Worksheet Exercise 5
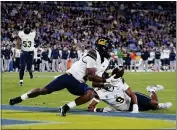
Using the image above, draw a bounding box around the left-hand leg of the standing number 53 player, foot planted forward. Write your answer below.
[19,51,26,86]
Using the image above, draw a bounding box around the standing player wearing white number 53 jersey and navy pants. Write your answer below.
[16,22,36,86]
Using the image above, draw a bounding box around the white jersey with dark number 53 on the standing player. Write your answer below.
[18,31,36,51]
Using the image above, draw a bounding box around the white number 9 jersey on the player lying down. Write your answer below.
[96,78,131,111]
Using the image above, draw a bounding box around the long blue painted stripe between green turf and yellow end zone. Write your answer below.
[1,105,176,120]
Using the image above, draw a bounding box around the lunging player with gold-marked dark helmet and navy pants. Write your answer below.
[9,38,117,116]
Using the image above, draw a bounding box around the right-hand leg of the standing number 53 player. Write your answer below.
[26,52,34,79]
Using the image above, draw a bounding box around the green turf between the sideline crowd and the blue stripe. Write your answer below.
[2,72,176,114]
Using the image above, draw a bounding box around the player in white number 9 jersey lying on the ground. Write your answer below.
[88,68,172,113]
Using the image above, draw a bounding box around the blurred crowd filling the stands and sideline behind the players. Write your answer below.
[1,1,176,71]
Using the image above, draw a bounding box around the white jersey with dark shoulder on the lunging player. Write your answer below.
[67,50,101,82]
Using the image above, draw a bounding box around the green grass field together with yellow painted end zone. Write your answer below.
[2,72,176,129]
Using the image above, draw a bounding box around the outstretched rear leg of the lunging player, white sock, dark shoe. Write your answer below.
[9,74,68,105]
